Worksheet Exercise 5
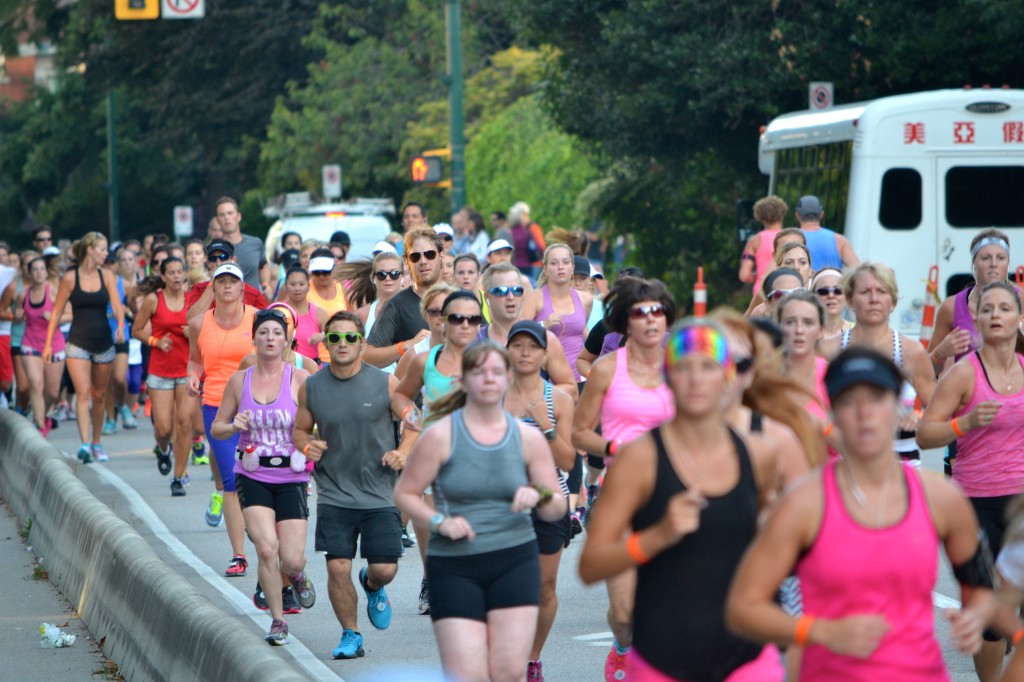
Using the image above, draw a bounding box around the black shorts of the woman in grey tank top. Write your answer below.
[427,541,541,623]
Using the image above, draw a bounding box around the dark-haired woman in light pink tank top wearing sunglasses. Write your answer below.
[572,278,676,680]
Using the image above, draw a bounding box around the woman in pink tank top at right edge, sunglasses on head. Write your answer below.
[918,281,1024,681]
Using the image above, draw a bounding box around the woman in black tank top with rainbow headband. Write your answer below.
[580,319,784,682]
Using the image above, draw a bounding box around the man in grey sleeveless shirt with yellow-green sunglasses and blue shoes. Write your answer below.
[294,311,414,658]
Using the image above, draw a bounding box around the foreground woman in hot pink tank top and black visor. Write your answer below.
[726,347,995,682]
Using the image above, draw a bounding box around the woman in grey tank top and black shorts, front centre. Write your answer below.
[394,341,565,680]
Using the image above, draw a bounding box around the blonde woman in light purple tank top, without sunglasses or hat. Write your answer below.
[522,244,594,383]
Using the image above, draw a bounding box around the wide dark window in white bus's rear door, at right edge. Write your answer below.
[946,166,1024,227]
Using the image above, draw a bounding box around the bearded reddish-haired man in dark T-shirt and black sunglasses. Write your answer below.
[364,228,443,368]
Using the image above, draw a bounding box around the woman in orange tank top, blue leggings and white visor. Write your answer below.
[187,262,260,578]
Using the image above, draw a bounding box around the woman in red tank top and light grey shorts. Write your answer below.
[131,257,196,489]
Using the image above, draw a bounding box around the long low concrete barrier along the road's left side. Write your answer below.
[0,410,308,682]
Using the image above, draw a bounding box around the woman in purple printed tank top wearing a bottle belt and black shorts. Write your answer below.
[207,306,316,646]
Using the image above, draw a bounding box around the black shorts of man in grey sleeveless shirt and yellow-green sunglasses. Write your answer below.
[313,504,401,563]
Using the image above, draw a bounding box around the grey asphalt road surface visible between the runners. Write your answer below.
[37,411,977,682]
